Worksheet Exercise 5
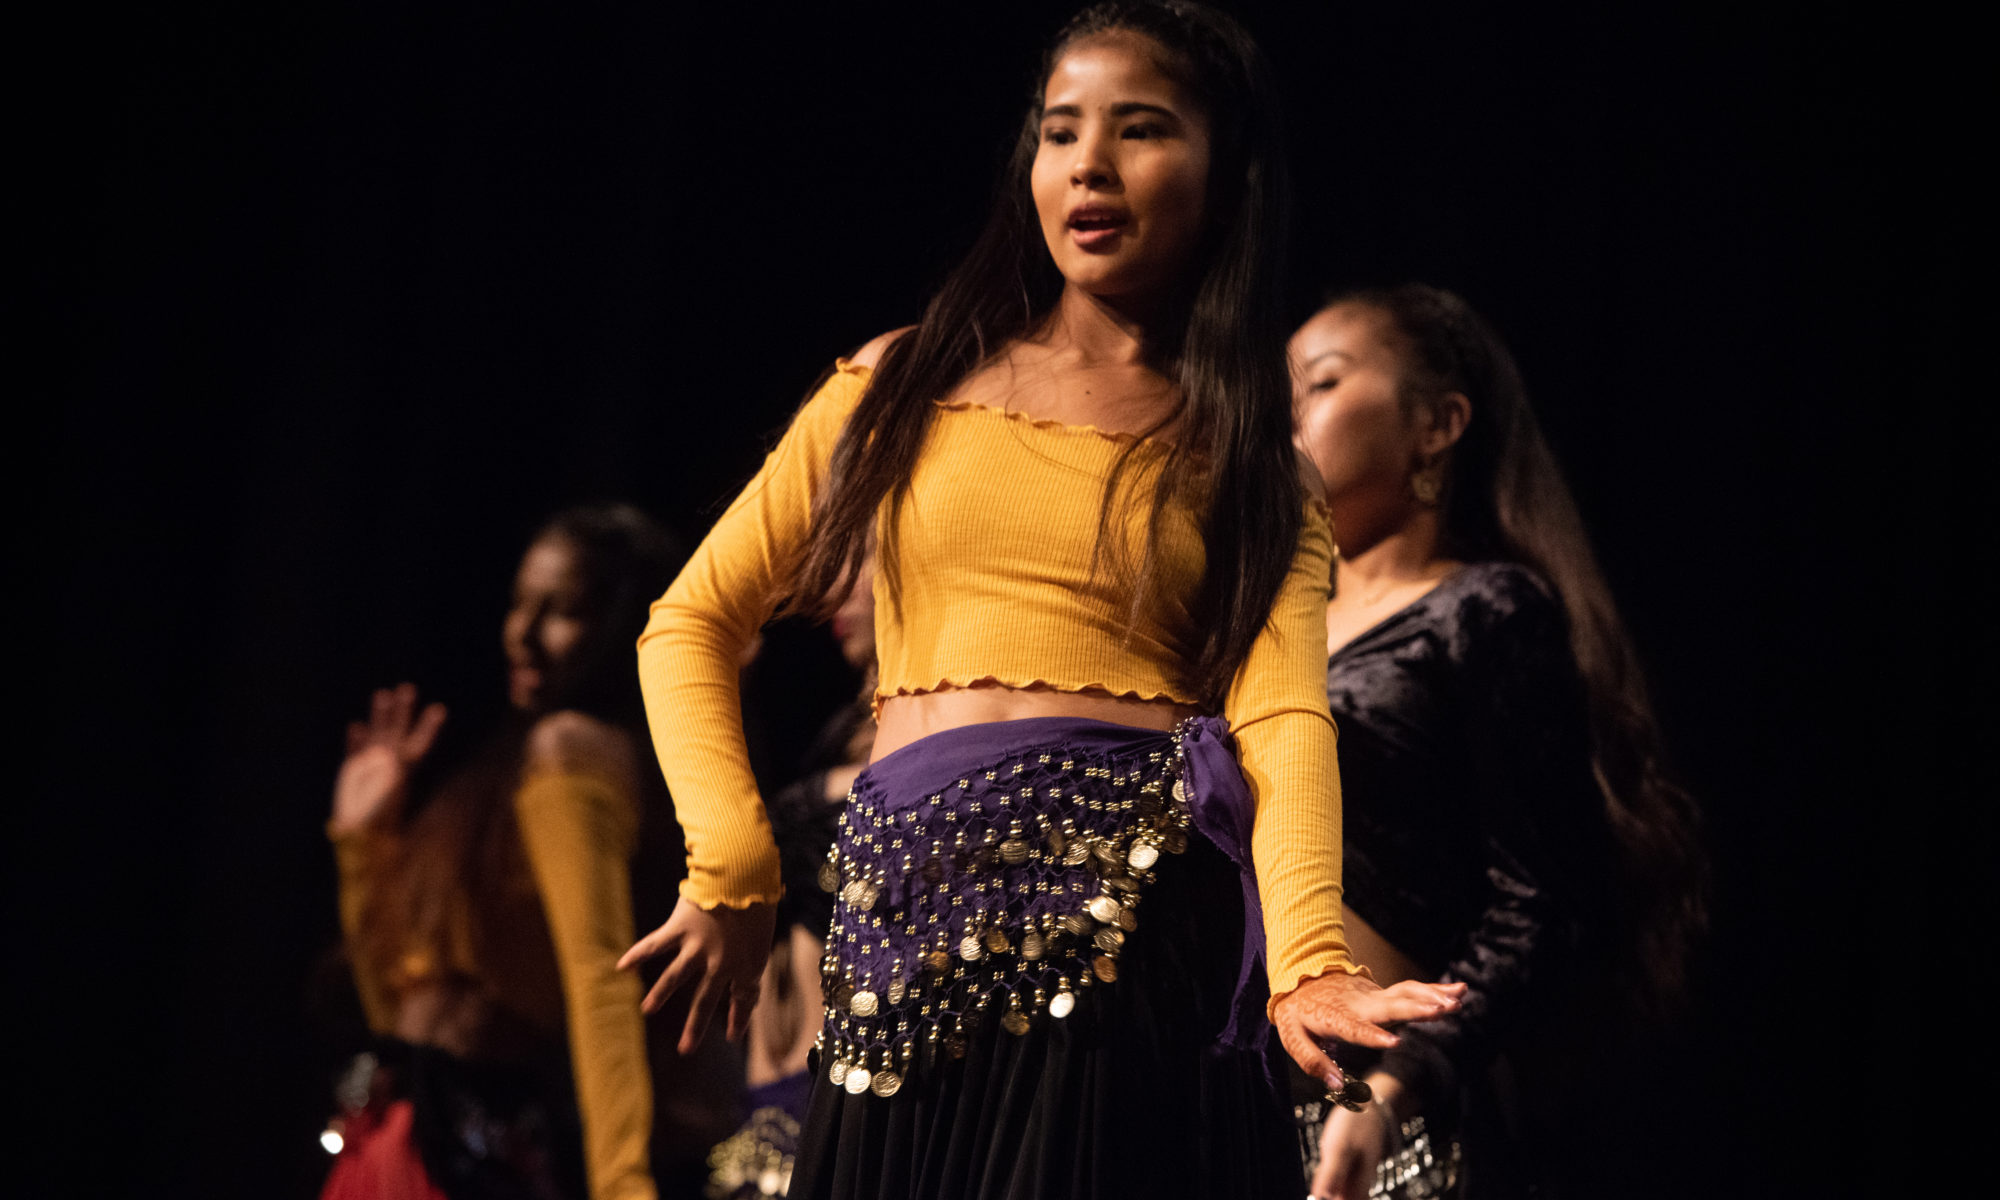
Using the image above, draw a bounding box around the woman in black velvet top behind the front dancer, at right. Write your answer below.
[1290,284,1702,1200]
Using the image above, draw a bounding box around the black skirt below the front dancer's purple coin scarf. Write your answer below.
[790,722,1302,1200]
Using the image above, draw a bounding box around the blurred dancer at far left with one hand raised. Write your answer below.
[326,506,732,1200]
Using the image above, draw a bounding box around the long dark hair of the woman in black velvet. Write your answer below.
[1322,284,1706,1016]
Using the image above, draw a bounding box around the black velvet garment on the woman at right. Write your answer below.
[1326,562,1612,1200]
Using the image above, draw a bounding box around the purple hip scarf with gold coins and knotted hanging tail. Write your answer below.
[818,716,1268,1096]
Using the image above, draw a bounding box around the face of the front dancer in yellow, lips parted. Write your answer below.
[1032,32,1208,298]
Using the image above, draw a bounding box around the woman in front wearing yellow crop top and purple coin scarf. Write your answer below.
[628,2,1456,1200]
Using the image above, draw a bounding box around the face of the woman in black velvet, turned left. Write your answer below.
[1290,304,1428,504]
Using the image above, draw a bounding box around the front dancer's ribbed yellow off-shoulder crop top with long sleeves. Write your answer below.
[638,362,1360,998]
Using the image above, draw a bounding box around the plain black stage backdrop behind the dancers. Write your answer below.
[35,2,1984,1196]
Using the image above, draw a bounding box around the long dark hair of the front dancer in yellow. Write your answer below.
[792,0,1302,704]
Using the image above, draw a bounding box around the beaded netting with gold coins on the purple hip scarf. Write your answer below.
[818,732,1190,1096]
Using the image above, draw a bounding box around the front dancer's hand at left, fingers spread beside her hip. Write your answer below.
[618,896,778,1054]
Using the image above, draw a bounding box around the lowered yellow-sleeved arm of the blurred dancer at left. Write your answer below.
[514,712,656,1200]
